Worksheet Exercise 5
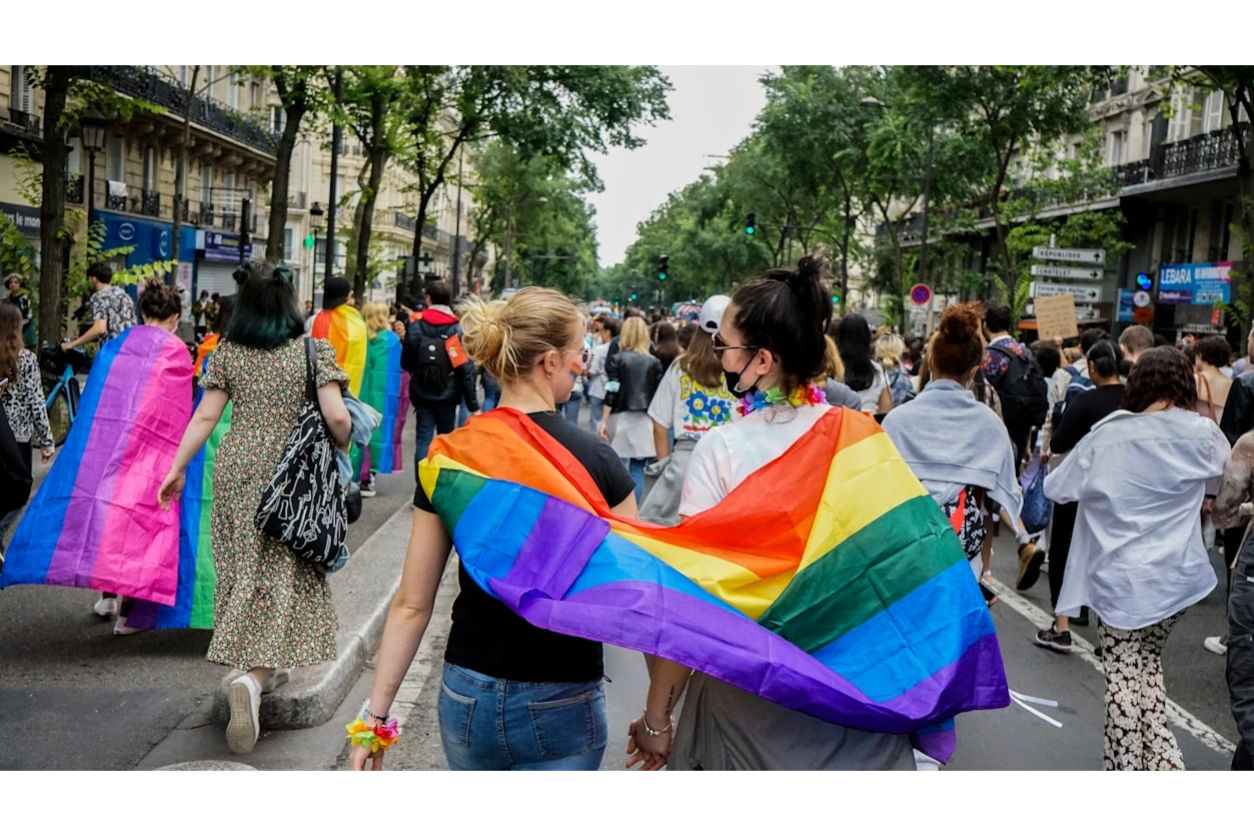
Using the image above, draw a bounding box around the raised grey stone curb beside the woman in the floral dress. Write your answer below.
[212,505,414,731]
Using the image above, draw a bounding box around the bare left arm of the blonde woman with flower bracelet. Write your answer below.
[351,508,453,772]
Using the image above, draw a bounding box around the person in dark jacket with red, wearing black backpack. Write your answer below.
[400,281,476,479]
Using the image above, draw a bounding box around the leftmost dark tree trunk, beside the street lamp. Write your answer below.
[39,64,71,345]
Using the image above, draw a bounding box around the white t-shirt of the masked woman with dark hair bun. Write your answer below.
[680,404,831,516]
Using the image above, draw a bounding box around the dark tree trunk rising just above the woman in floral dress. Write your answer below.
[239,64,329,264]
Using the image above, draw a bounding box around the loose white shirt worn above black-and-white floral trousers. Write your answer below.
[1045,409,1230,630]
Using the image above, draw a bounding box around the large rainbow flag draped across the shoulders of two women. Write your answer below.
[420,409,1009,761]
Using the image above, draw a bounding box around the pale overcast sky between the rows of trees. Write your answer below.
[592,64,775,266]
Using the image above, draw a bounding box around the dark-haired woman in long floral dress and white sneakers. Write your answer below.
[161,267,351,755]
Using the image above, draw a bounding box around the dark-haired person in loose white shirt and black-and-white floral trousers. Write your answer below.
[1045,347,1230,772]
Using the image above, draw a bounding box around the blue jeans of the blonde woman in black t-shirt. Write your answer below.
[439,663,608,773]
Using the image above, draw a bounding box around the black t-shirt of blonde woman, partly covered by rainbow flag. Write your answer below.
[414,412,636,682]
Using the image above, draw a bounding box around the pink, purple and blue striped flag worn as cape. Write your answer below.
[0,325,192,604]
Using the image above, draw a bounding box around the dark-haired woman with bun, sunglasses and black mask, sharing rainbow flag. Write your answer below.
[630,258,915,775]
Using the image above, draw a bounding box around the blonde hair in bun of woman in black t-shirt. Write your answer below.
[461,287,583,381]
